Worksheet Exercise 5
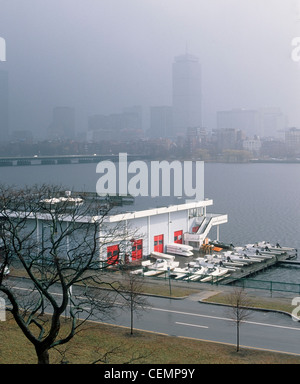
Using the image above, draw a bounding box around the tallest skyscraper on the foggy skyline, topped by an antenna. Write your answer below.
[172,53,202,136]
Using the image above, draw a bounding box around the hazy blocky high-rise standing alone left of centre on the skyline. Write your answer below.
[48,107,75,140]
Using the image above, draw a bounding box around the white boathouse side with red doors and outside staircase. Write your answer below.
[101,199,228,260]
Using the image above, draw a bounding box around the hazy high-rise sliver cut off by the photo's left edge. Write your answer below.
[0,71,9,145]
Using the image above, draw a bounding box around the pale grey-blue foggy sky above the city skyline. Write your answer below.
[0,0,300,136]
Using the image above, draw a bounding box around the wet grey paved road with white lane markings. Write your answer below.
[2,279,300,355]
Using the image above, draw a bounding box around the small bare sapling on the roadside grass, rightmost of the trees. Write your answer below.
[227,287,251,352]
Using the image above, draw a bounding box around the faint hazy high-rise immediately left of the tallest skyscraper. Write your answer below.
[149,105,173,137]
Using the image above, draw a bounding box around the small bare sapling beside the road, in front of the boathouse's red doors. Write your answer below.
[122,269,149,335]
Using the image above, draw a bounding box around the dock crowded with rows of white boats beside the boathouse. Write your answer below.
[132,242,300,285]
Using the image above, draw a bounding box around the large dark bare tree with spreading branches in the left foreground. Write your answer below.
[0,185,137,364]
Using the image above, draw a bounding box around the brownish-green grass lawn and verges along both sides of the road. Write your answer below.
[0,268,300,364]
